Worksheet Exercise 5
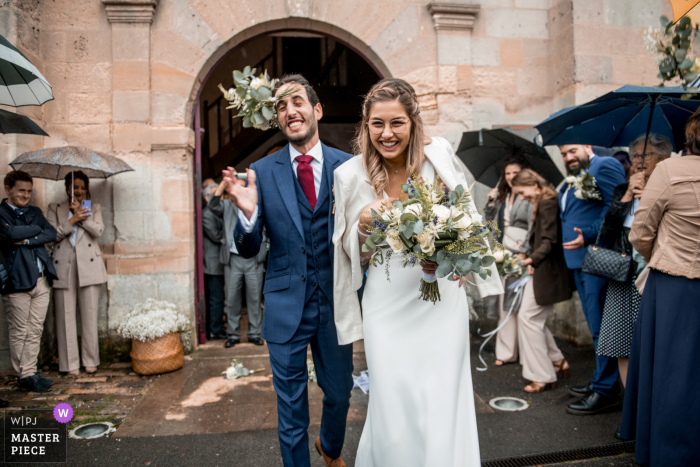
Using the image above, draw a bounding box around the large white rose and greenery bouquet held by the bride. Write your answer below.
[362,175,495,303]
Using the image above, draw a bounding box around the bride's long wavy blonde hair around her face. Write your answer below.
[353,78,425,194]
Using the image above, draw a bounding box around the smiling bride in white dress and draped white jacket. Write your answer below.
[333,79,503,467]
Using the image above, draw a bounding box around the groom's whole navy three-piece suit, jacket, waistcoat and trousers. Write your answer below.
[233,145,353,467]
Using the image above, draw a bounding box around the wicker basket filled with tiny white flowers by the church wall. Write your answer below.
[118,298,190,375]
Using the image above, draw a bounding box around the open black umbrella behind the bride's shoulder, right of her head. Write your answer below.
[457,129,564,187]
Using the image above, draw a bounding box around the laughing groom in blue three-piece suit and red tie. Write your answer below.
[224,75,353,467]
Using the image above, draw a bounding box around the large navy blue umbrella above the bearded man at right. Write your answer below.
[536,86,700,152]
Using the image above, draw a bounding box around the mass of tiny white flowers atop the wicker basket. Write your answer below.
[118,298,190,341]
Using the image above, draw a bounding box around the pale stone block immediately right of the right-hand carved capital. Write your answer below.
[479,9,549,39]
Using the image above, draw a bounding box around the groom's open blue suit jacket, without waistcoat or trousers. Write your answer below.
[233,144,352,344]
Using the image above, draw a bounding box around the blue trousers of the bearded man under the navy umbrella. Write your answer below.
[573,269,619,396]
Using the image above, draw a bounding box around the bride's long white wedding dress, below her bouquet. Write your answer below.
[355,161,481,467]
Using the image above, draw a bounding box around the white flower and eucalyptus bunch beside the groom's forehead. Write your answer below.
[219,66,292,131]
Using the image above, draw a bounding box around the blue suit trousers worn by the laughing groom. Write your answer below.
[267,289,353,467]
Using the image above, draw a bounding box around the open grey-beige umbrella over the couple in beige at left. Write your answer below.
[10,146,134,200]
